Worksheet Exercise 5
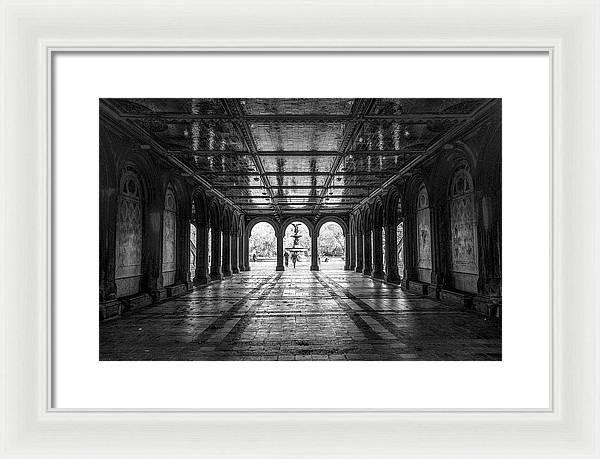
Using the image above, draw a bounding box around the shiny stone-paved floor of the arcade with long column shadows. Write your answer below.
[100,263,502,360]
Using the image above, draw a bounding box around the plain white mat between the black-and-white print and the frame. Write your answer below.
[53,54,551,409]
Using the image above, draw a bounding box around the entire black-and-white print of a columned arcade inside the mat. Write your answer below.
[99,98,502,361]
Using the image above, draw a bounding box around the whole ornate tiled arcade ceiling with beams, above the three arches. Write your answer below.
[100,98,491,217]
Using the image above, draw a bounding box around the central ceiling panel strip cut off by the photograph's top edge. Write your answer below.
[240,99,353,115]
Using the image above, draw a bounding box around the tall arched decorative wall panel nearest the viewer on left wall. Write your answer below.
[115,167,144,297]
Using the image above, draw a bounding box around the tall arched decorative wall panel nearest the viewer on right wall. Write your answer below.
[450,165,479,293]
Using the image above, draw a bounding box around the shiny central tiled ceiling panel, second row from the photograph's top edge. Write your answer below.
[250,122,344,151]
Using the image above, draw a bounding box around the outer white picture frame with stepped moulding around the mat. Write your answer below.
[0,0,600,458]
